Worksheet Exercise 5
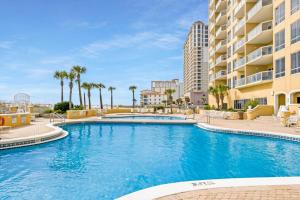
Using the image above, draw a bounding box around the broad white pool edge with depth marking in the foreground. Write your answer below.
[117,176,300,200]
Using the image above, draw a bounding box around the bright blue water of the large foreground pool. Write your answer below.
[0,123,300,200]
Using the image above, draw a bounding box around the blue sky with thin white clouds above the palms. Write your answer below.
[0,0,208,104]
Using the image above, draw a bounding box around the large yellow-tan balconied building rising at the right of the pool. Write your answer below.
[209,0,300,111]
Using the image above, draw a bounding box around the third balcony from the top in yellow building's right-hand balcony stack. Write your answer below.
[247,45,273,65]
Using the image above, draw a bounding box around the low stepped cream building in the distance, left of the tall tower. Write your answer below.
[140,79,183,106]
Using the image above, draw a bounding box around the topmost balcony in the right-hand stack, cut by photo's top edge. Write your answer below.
[247,0,273,23]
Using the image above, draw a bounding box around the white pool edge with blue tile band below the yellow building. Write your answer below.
[196,123,300,143]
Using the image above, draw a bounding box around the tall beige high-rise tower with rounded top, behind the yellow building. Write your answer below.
[184,21,208,105]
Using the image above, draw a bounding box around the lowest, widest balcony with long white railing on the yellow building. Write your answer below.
[237,71,273,88]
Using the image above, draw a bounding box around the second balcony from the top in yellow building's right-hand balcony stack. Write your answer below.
[247,20,273,44]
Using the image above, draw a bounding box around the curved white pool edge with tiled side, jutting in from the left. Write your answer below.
[0,124,69,150]
